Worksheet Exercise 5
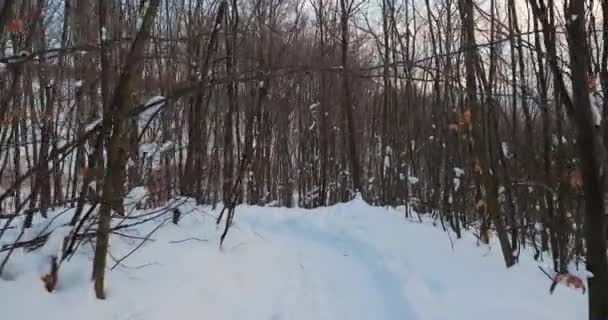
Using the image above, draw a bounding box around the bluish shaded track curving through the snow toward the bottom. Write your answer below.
[245,215,417,320]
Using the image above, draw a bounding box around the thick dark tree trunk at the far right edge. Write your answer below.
[566,1,608,320]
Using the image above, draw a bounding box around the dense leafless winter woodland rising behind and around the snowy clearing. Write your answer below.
[0,0,608,319]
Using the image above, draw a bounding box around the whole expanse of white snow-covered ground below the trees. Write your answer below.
[0,200,587,320]
